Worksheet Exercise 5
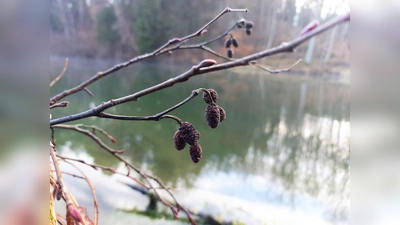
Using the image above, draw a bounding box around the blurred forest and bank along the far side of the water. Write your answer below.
[50,0,350,75]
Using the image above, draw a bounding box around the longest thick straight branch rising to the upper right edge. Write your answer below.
[50,13,350,125]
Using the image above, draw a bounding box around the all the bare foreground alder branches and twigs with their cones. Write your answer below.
[50,8,350,225]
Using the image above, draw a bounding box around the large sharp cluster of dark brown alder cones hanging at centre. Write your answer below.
[173,89,226,163]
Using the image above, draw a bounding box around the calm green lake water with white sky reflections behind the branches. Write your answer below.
[50,57,350,225]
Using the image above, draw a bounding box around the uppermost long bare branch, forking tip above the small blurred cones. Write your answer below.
[50,8,248,105]
